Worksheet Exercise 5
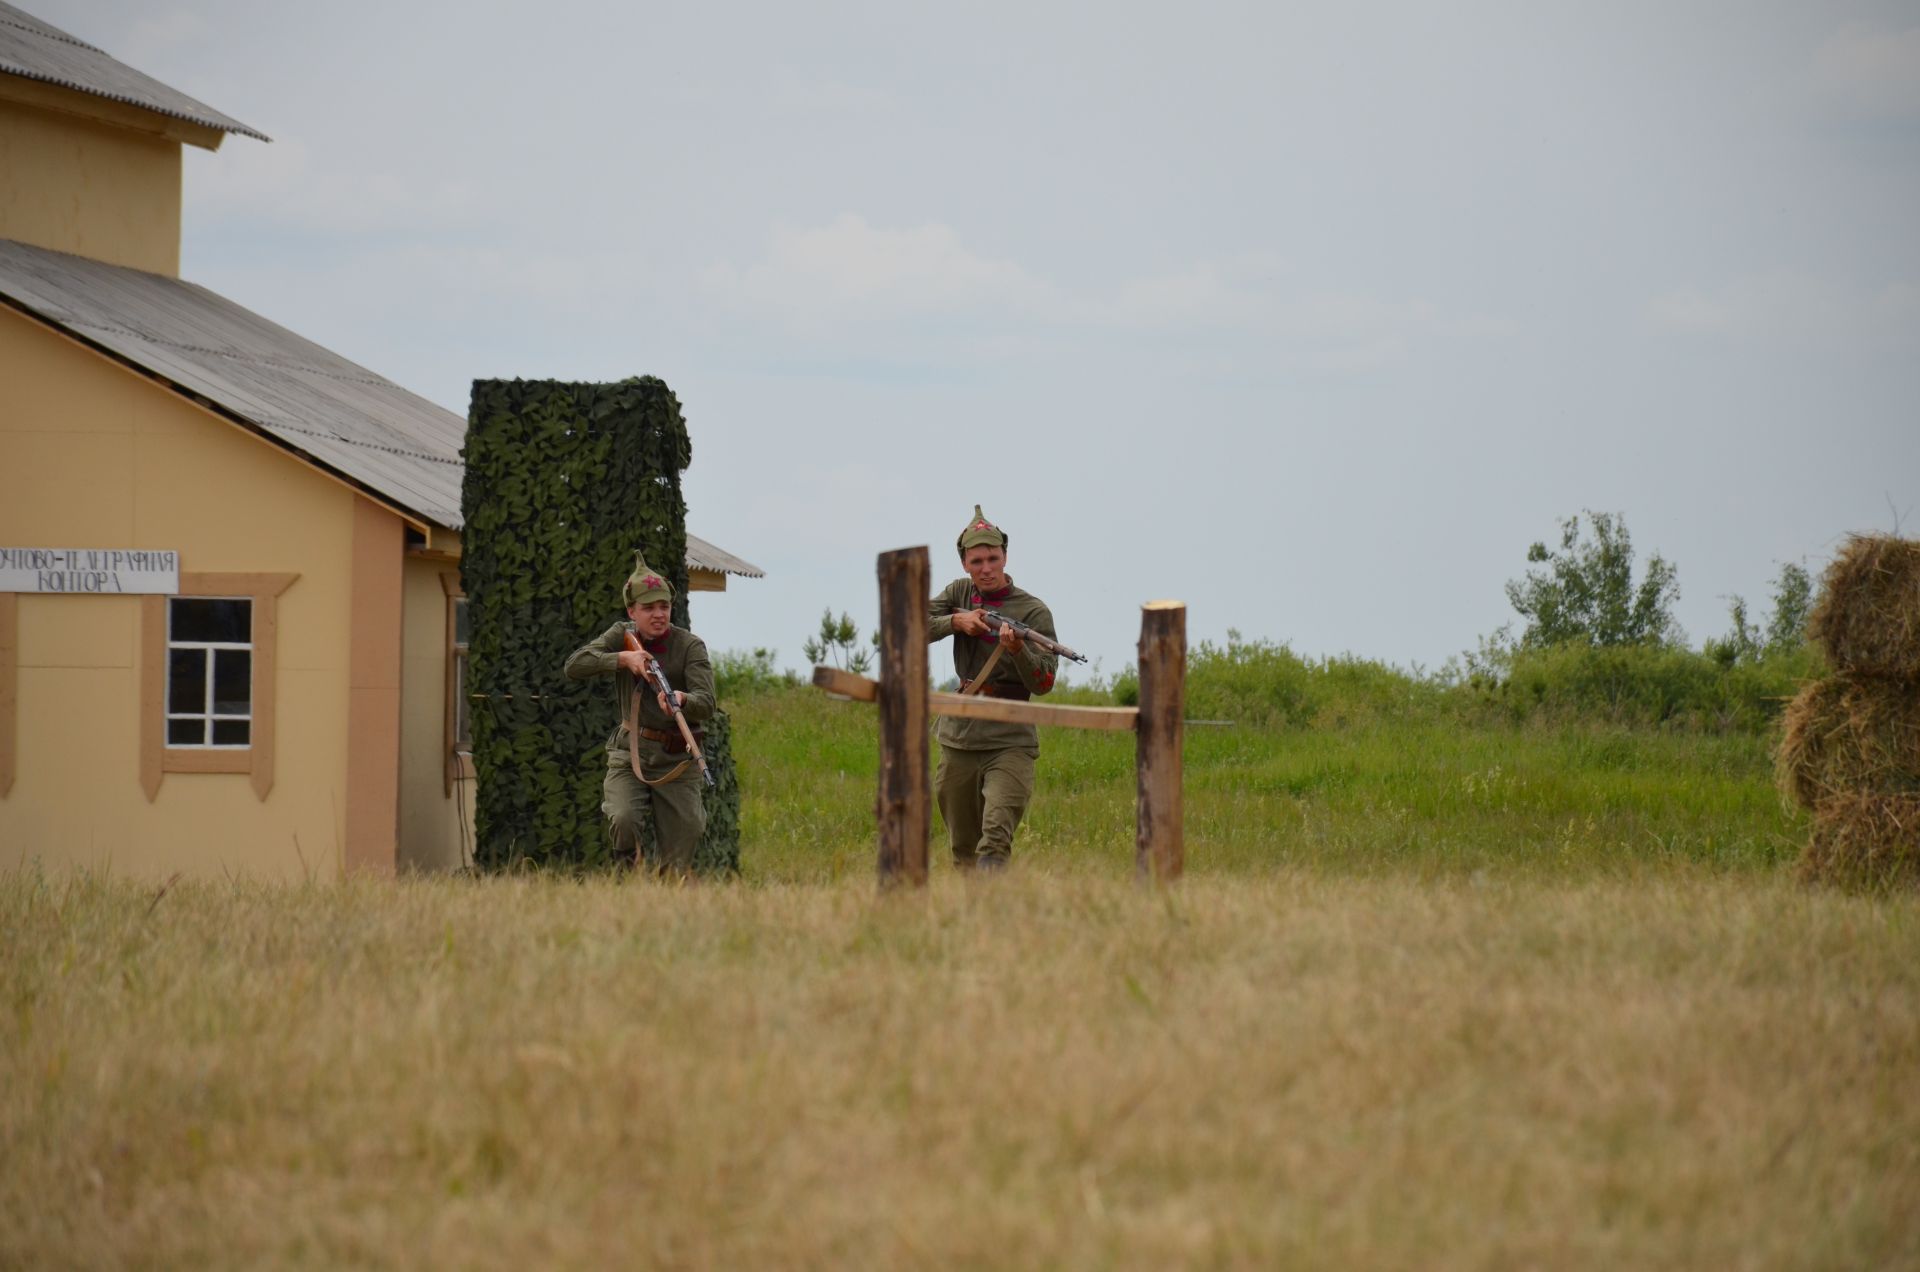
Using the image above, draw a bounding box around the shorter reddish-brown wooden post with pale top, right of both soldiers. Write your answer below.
[1133,601,1187,884]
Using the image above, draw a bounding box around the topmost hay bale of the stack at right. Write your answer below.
[1807,534,1920,680]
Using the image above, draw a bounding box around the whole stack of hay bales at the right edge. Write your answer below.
[1776,536,1920,888]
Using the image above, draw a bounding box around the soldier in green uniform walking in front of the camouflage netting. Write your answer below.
[564,551,714,874]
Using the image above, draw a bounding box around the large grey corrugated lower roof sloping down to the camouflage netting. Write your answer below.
[0,238,467,530]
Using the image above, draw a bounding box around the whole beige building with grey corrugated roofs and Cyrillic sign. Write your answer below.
[0,2,758,878]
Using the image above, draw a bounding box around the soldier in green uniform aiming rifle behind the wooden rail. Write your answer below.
[927,503,1060,870]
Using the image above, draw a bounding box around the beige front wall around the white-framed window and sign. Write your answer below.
[0,301,357,878]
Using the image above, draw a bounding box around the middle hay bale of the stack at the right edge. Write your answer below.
[1774,674,1920,809]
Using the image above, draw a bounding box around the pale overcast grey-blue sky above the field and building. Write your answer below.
[33,0,1920,673]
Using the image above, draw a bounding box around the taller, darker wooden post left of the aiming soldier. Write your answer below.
[874,548,933,888]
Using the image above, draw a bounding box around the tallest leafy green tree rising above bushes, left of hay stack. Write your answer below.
[1507,511,1680,649]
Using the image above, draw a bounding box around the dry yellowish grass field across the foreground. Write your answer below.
[0,863,1920,1268]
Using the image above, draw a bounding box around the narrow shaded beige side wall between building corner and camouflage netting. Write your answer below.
[399,557,474,870]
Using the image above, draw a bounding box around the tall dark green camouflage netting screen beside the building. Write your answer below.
[461,377,739,870]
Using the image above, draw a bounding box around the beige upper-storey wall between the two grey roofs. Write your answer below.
[0,100,180,277]
